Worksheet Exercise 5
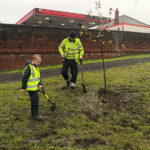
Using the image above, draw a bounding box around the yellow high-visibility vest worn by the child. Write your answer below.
[24,64,40,91]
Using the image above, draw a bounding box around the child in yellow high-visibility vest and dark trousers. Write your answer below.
[20,54,42,121]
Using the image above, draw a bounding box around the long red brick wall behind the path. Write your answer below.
[0,24,150,70]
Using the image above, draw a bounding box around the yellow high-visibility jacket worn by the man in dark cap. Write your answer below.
[58,37,84,62]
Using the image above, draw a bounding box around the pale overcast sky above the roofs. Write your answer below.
[0,0,150,25]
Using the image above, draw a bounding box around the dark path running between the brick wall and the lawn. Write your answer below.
[0,57,150,83]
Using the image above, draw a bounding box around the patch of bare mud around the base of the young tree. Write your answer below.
[78,88,143,121]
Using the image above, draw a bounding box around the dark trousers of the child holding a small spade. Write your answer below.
[29,91,39,116]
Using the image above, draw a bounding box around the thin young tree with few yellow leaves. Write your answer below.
[80,0,113,94]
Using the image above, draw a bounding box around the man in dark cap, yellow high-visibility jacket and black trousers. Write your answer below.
[59,31,84,91]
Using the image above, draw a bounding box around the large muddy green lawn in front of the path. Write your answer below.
[0,59,150,150]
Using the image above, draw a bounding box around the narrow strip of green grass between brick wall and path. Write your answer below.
[0,54,150,74]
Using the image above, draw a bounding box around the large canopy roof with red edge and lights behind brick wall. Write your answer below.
[16,8,110,28]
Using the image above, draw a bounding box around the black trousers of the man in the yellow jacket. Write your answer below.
[61,59,78,83]
